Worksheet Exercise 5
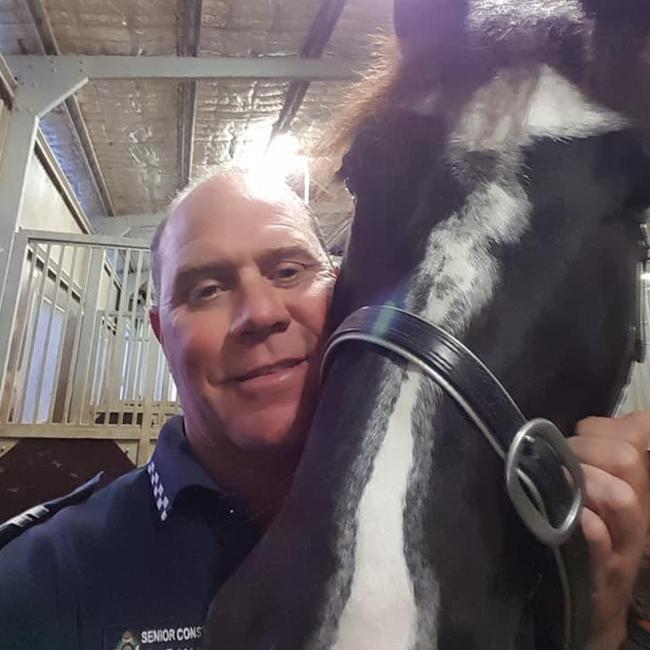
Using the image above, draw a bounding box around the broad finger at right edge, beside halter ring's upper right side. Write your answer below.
[569,436,648,496]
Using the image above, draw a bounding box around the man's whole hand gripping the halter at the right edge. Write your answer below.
[569,413,650,650]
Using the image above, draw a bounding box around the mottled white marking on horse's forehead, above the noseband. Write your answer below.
[411,65,626,336]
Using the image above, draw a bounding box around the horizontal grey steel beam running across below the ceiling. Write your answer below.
[5,54,357,83]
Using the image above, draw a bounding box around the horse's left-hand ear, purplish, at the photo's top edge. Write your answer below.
[393,0,469,58]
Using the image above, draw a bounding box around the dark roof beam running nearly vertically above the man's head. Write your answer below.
[178,0,203,187]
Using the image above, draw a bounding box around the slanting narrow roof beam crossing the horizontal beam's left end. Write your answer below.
[24,0,115,216]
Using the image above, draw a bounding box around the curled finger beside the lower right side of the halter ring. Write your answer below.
[582,465,646,553]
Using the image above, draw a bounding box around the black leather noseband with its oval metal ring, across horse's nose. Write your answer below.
[323,305,584,546]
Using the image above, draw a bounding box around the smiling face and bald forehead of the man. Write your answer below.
[152,177,333,451]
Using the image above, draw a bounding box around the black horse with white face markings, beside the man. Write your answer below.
[204,0,650,650]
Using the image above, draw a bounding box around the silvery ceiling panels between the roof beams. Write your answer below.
[0,0,392,240]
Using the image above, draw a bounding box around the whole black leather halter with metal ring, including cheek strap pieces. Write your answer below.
[322,223,650,650]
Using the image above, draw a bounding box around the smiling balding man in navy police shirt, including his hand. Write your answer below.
[0,170,650,650]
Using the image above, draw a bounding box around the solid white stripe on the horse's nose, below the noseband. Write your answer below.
[334,369,420,650]
